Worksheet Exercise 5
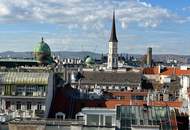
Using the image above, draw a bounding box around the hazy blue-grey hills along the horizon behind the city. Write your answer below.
[0,51,190,64]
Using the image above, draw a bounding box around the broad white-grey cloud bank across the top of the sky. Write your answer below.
[0,0,187,29]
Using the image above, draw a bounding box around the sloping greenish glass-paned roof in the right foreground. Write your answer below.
[116,106,175,130]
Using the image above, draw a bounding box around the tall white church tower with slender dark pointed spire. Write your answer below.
[107,12,118,69]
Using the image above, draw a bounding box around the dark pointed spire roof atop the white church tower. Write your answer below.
[109,11,118,42]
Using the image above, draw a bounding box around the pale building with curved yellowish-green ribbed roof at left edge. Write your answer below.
[0,69,53,119]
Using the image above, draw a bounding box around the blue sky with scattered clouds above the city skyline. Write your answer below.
[0,0,190,55]
